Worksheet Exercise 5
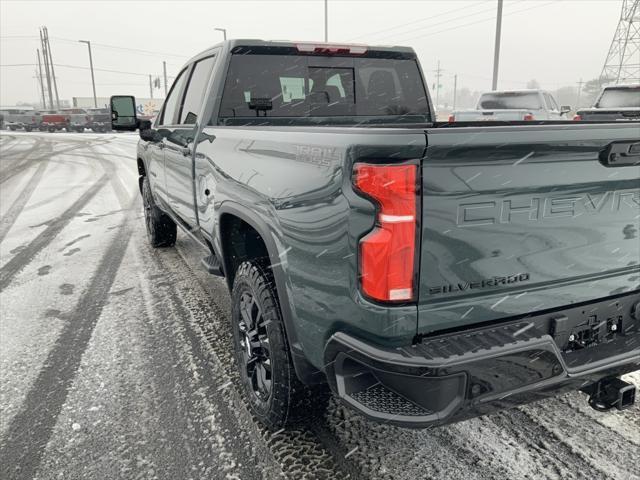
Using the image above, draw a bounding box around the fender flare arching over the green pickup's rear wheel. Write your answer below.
[216,201,326,385]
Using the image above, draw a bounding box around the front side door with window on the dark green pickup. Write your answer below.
[145,68,189,206]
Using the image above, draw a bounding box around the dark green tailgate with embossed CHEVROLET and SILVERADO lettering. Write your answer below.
[418,124,640,334]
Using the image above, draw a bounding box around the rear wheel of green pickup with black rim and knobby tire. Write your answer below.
[231,261,330,430]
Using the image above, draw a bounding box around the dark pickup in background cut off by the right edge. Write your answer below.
[574,84,640,121]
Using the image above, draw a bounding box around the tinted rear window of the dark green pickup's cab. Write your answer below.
[220,54,429,125]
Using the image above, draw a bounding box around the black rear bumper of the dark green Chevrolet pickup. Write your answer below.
[325,292,640,427]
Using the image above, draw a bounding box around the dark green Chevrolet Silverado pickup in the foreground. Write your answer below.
[112,40,640,428]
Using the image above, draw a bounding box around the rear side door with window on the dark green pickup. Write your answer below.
[163,55,216,226]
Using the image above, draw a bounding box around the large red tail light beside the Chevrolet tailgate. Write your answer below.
[353,163,419,302]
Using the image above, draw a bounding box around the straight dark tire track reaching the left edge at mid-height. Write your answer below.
[0,174,108,292]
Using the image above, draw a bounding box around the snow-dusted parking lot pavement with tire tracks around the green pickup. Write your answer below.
[0,132,640,480]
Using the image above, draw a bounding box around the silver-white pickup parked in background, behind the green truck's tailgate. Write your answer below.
[449,90,571,122]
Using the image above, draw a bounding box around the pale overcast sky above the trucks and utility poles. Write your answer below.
[0,0,621,105]
